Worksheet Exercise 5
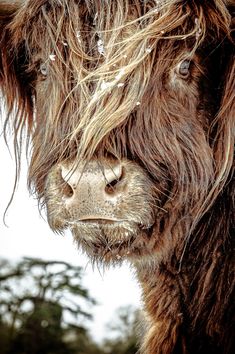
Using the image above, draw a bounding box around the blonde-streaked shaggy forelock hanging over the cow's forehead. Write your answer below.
[2,0,230,165]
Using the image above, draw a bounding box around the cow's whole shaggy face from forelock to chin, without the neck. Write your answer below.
[1,0,232,261]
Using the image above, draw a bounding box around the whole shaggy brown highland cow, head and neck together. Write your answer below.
[0,0,235,354]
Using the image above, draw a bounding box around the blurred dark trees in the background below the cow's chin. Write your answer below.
[0,258,139,354]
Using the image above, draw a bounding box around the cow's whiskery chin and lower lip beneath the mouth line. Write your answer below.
[70,220,152,264]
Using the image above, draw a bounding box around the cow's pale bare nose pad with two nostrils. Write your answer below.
[61,161,124,203]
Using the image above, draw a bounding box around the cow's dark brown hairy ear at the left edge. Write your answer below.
[0,1,33,132]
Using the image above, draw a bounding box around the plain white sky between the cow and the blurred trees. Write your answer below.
[0,130,140,341]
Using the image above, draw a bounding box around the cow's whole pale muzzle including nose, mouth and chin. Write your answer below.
[45,158,155,260]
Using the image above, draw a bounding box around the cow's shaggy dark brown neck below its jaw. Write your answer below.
[133,178,235,354]
